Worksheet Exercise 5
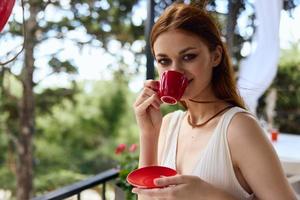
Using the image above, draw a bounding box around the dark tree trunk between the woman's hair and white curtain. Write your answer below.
[226,0,243,57]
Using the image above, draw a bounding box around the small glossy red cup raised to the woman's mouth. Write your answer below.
[159,71,188,105]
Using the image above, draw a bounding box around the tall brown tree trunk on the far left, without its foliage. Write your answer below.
[17,1,38,200]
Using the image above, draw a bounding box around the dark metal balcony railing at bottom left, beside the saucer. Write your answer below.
[32,169,119,200]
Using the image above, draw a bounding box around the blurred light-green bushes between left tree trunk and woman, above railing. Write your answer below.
[35,80,138,192]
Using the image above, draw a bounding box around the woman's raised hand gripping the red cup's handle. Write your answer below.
[134,80,162,134]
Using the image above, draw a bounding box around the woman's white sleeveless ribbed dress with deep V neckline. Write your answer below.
[160,107,254,200]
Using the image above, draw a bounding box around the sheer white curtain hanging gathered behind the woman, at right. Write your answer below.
[238,0,283,114]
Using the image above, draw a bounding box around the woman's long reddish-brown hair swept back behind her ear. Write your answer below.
[150,3,245,108]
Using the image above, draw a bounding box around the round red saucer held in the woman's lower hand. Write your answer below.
[127,166,177,188]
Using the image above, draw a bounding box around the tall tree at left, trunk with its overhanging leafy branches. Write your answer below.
[1,0,143,200]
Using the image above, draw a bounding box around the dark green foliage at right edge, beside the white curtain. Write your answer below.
[272,44,300,133]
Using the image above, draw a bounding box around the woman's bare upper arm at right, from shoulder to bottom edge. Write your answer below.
[227,113,296,200]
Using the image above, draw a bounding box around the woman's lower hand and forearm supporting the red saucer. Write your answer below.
[132,175,234,200]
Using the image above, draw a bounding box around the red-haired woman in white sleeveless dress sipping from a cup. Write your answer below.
[133,4,295,200]
